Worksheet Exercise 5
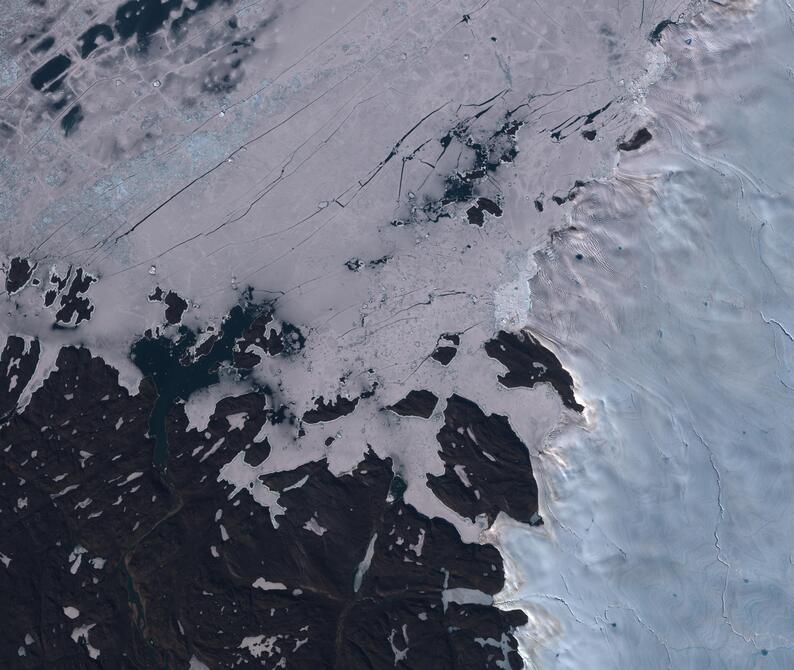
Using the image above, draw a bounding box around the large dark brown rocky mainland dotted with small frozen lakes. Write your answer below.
[0,348,527,670]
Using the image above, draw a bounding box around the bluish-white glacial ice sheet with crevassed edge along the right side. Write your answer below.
[492,2,794,669]
